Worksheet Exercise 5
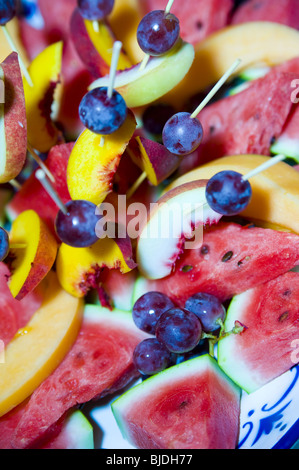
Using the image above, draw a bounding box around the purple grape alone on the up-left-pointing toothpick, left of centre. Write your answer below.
[55,200,102,248]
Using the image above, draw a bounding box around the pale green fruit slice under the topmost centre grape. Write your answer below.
[89,41,194,108]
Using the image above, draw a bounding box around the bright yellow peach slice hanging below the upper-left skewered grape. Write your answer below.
[67,110,136,205]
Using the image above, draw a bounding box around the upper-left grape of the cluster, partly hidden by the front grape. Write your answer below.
[132,292,174,335]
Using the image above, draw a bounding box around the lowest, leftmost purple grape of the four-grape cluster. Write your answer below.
[133,338,172,375]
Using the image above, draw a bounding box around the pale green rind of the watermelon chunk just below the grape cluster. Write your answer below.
[111,354,241,445]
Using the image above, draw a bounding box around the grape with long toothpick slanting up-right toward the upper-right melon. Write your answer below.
[162,59,241,156]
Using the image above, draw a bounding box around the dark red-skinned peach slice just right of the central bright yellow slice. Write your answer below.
[127,136,181,186]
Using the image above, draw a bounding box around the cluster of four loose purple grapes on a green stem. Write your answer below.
[132,292,226,375]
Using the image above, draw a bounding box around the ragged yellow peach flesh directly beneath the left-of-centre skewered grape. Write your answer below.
[56,238,135,297]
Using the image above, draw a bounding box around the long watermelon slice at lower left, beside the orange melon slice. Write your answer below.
[11,305,148,448]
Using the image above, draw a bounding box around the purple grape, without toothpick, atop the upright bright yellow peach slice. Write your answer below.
[79,87,127,135]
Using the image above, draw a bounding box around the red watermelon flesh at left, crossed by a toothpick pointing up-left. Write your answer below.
[7,143,74,233]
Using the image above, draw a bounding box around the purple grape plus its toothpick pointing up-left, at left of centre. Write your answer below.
[35,169,102,248]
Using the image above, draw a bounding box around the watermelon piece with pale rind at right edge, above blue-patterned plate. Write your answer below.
[218,272,299,393]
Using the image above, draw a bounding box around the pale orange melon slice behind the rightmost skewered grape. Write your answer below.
[167,155,299,233]
